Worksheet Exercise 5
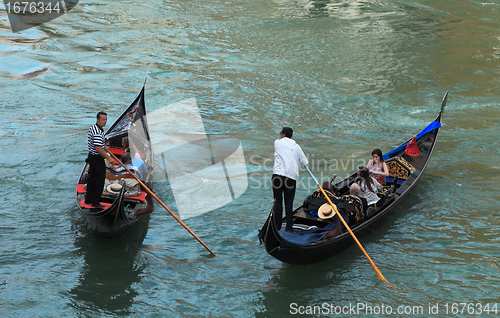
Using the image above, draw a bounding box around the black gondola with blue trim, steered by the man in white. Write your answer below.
[259,92,448,265]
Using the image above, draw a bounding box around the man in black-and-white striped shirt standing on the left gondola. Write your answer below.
[85,112,114,208]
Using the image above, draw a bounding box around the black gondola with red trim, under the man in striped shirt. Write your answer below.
[76,86,154,238]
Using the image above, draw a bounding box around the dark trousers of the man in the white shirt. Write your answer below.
[272,174,297,230]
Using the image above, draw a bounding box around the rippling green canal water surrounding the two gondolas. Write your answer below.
[0,0,500,317]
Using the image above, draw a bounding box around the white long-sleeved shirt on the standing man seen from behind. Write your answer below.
[273,137,309,180]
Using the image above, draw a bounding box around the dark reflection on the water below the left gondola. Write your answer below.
[69,214,150,315]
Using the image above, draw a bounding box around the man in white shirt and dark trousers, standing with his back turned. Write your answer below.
[272,127,308,231]
